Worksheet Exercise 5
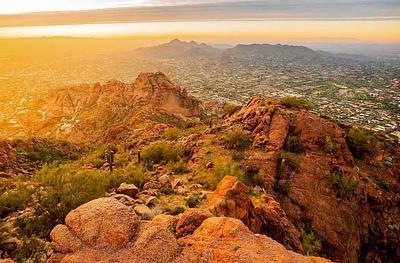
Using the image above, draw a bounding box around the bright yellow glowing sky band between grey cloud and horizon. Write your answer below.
[0,21,400,42]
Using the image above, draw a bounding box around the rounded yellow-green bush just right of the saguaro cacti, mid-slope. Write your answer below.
[142,141,179,165]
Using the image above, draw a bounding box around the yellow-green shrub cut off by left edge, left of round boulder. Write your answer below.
[0,180,34,215]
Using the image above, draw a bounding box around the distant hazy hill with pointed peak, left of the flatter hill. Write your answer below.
[133,39,222,58]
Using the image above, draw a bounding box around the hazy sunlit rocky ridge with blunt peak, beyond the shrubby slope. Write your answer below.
[45,72,200,119]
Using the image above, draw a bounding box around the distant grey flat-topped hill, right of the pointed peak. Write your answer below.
[222,44,319,59]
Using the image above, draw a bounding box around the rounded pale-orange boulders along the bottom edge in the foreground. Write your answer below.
[48,198,329,263]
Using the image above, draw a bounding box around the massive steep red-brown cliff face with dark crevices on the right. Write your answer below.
[224,97,400,262]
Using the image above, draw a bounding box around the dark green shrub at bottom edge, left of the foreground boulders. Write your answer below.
[16,237,50,263]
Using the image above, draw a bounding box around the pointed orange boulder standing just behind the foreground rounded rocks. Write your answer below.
[208,176,261,233]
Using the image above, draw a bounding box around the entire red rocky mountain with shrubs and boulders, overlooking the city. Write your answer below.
[0,73,400,263]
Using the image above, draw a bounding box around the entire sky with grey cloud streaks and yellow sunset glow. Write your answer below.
[0,0,400,43]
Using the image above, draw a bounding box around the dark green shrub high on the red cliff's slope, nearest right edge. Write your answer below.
[346,127,376,159]
